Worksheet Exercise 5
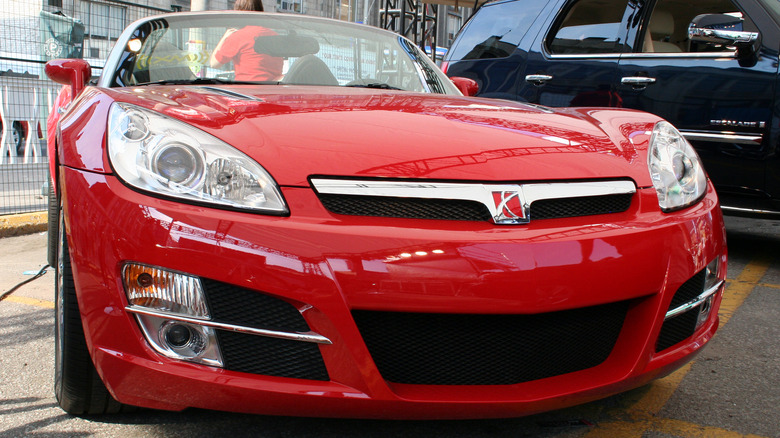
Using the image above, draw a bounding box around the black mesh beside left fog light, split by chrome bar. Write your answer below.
[201,279,328,380]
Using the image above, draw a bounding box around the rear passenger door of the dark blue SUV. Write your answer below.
[518,0,638,106]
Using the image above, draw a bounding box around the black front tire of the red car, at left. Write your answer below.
[54,209,126,415]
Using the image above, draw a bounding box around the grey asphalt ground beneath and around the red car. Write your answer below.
[0,217,780,438]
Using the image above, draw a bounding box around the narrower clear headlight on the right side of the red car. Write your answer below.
[647,122,707,212]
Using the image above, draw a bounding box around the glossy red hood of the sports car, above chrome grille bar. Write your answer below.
[106,86,659,187]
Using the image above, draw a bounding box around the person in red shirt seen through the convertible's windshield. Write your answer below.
[209,0,284,81]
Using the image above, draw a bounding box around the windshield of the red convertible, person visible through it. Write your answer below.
[111,12,458,94]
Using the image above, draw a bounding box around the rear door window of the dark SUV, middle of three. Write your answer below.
[547,0,628,54]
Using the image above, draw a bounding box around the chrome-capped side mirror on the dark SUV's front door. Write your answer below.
[688,14,761,66]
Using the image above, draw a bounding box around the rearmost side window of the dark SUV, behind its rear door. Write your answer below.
[442,0,545,61]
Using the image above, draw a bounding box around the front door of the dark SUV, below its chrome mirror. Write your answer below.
[617,0,780,208]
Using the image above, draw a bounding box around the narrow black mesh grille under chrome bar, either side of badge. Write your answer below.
[319,194,633,221]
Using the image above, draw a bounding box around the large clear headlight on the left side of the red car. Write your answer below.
[108,103,287,214]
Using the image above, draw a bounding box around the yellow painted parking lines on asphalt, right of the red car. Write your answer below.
[585,260,769,438]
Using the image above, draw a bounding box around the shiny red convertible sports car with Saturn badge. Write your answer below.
[46,12,726,419]
